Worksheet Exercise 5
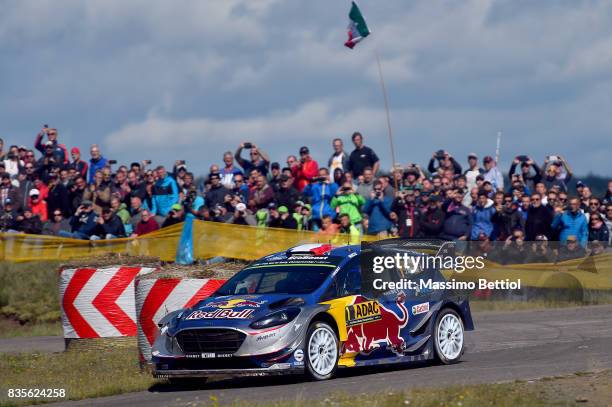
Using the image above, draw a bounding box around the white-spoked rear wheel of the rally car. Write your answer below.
[433,308,465,365]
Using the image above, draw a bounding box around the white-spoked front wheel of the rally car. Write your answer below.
[304,321,340,380]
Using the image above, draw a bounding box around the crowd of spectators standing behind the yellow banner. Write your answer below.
[0,126,612,260]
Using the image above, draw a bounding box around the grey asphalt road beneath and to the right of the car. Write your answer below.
[4,306,612,407]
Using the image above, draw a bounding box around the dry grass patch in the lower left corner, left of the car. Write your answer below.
[0,348,155,406]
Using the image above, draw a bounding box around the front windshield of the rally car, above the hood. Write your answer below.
[216,264,336,295]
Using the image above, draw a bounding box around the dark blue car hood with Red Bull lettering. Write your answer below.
[169,294,305,335]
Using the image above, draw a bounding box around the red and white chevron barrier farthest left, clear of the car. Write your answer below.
[60,266,155,338]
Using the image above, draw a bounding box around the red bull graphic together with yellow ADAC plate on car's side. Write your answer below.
[344,295,408,353]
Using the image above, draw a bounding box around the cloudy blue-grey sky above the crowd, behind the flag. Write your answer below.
[0,0,612,175]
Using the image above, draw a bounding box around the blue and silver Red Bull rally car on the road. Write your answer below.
[152,239,474,380]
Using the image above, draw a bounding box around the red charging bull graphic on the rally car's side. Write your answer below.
[343,293,408,353]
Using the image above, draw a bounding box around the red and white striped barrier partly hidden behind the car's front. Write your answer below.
[136,278,225,361]
